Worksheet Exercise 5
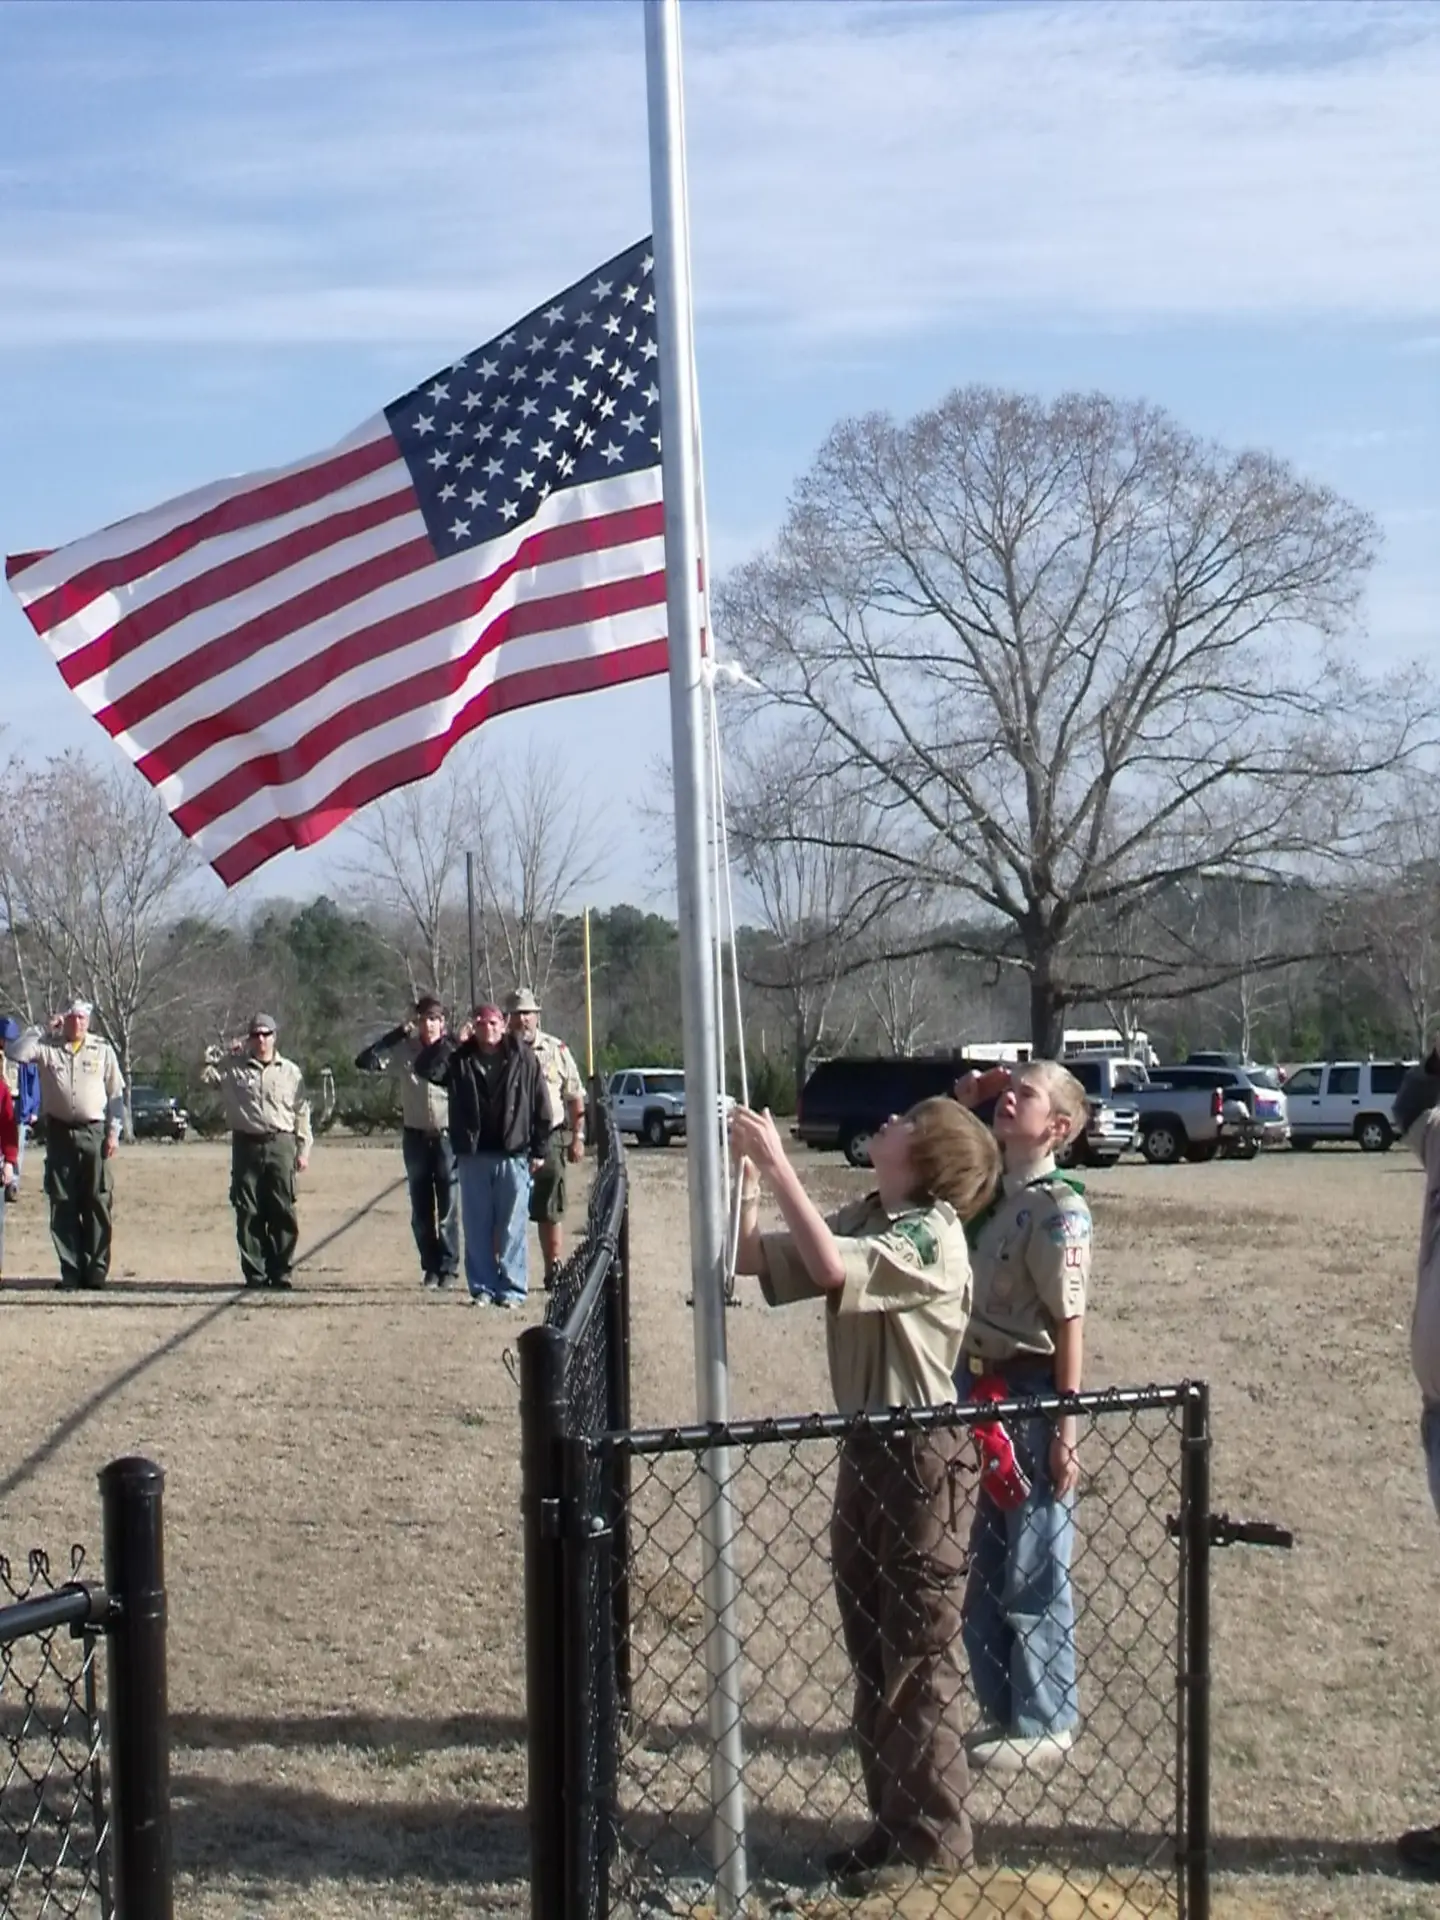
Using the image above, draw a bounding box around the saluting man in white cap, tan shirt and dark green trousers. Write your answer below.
[6,1000,125,1292]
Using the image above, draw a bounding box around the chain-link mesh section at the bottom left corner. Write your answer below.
[0,1548,111,1916]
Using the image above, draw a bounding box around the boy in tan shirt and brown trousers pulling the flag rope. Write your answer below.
[730,1100,1000,1889]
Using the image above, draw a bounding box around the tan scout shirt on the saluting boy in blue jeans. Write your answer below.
[966,1164,1091,1361]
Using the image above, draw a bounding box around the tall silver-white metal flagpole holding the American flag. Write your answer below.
[645,0,747,1916]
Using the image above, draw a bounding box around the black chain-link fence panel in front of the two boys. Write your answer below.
[532,1386,1212,1920]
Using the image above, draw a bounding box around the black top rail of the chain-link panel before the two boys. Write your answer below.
[588,1380,1206,1453]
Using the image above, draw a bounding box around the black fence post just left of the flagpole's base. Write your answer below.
[518,1327,568,1920]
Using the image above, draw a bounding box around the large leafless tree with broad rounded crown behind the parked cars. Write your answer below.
[720,388,1427,1050]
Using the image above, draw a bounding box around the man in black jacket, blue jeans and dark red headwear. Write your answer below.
[420,1006,549,1308]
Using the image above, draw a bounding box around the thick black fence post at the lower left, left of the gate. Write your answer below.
[100,1455,173,1920]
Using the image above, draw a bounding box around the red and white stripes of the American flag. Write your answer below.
[6,417,666,885]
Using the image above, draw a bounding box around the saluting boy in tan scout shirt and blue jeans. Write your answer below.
[956,1060,1091,1772]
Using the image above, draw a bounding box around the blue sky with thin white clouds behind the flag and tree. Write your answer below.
[0,0,1440,899]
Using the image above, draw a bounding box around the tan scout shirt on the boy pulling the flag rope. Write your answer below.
[760,1194,970,1413]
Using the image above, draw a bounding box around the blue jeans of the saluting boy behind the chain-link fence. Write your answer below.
[956,1363,1079,1738]
